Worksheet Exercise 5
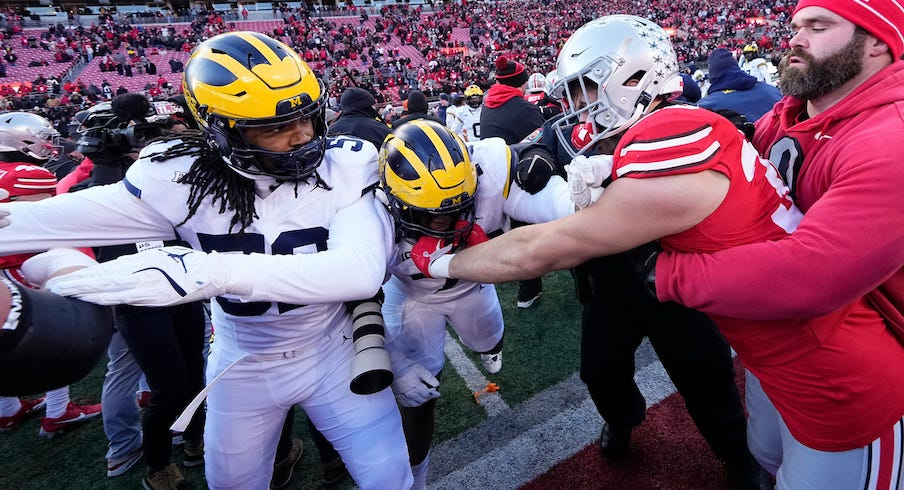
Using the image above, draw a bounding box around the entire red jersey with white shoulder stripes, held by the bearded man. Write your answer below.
[613,106,900,451]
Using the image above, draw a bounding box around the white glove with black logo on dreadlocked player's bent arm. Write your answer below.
[47,247,229,306]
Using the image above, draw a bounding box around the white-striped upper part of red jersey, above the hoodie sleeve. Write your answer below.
[612,105,802,252]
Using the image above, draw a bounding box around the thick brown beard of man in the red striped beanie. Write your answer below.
[779,30,866,100]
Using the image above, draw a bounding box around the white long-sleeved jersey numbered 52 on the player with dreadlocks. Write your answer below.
[0,137,392,354]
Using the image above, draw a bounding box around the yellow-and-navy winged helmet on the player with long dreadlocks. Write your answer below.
[183,32,327,181]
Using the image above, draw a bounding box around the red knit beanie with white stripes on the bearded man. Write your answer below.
[794,0,904,60]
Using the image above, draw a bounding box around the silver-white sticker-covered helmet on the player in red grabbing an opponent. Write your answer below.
[553,15,682,156]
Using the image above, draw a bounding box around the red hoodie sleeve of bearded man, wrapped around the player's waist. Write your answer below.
[656,133,904,320]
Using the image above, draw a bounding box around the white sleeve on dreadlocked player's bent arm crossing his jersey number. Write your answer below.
[223,192,392,304]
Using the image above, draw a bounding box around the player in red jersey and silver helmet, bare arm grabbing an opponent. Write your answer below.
[412,13,904,488]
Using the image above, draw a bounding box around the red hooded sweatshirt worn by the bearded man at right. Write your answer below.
[656,61,904,448]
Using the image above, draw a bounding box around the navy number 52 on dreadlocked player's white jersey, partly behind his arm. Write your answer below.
[198,229,328,316]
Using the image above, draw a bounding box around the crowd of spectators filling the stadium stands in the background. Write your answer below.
[0,0,790,134]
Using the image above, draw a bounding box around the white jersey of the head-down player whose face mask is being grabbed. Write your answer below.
[390,138,574,304]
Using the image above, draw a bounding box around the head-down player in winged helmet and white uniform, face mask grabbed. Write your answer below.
[380,120,574,489]
